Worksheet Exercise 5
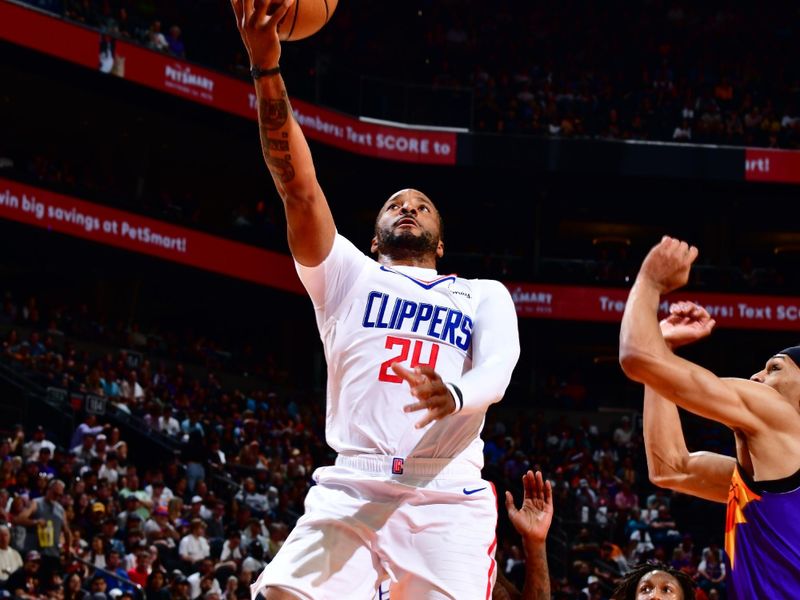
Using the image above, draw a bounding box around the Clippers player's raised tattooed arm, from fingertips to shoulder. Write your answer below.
[231,0,336,266]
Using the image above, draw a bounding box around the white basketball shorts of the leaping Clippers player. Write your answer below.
[251,455,497,600]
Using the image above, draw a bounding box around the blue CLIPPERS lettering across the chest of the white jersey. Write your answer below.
[361,291,473,351]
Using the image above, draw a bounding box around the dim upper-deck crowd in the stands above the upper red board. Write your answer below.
[10,0,800,148]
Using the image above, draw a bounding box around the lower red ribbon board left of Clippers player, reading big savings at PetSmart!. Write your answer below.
[0,178,304,294]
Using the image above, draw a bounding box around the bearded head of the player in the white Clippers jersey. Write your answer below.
[372,189,444,257]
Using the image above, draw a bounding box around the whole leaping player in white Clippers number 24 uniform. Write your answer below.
[231,0,519,600]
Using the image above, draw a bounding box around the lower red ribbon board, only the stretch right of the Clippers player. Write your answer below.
[506,282,800,331]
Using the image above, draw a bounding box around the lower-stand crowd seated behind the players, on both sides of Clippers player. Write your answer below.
[0,288,725,600]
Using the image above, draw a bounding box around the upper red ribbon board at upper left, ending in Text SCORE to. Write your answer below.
[0,0,457,165]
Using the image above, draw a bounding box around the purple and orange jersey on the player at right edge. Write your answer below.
[725,463,800,600]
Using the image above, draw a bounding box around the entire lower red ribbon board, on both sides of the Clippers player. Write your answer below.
[0,178,800,331]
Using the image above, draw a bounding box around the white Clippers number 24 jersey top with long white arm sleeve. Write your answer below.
[297,235,519,469]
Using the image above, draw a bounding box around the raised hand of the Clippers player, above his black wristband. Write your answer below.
[231,0,295,69]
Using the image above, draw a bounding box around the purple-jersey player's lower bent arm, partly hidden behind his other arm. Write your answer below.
[644,302,736,503]
